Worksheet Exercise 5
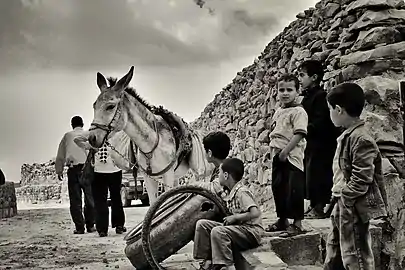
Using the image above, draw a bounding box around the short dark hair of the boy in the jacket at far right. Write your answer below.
[326,83,366,117]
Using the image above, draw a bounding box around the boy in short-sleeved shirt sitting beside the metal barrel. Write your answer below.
[194,158,263,270]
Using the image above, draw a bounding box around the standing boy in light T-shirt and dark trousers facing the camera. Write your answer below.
[266,74,308,236]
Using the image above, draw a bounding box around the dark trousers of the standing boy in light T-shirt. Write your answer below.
[271,154,305,220]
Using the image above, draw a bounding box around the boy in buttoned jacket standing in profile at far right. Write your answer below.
[324,83,387,270]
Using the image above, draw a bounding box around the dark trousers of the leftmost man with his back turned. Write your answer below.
[67,165,94,230]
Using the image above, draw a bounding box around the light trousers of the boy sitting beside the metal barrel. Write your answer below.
[193,219,260,266]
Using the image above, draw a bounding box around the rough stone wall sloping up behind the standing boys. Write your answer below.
[192,0,405,269]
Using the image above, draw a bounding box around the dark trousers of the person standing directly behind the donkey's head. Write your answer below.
[92,171,125,233]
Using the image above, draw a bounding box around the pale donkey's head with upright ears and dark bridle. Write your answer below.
[89,66,134,148]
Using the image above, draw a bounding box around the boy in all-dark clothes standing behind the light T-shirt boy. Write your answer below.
[298,60,338,218]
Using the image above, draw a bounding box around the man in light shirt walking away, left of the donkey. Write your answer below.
[55,116,95,234]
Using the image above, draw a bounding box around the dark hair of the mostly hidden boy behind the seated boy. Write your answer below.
[203,131,231,159]
